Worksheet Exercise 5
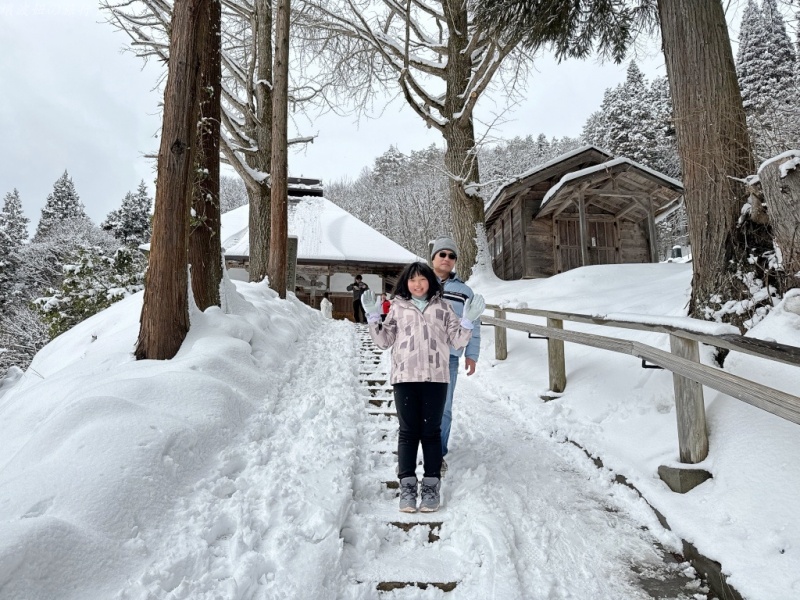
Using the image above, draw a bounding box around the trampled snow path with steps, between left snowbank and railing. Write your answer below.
[109,321,705,600]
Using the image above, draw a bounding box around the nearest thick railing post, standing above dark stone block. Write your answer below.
[669,335,708,464]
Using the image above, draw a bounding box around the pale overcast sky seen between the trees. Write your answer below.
[0,0,688,233]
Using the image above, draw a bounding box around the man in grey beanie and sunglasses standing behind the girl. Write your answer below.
[431,237,481,476]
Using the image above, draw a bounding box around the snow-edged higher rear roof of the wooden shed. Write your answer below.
[486,145,613,225]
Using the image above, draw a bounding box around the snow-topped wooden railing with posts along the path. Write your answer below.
[481,305,800,478]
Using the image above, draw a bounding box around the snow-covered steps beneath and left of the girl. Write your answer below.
[343,325,466,598]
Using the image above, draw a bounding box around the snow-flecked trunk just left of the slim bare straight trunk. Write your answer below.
[245,0,272,281]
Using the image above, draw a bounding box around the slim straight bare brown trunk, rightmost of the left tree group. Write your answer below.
[269,0,294,298]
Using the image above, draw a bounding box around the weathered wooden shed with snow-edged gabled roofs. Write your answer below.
[486,146,683,280]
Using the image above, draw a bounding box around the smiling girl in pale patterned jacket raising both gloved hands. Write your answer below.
[361,262,485,512]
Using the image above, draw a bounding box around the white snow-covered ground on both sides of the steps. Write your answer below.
[0,264,800,600]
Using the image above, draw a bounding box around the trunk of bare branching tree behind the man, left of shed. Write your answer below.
[442,0,485,279]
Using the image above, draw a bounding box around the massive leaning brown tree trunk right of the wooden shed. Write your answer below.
[658,0,754,328]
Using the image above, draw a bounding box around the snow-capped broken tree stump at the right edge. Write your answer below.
[758,156,800,289]
